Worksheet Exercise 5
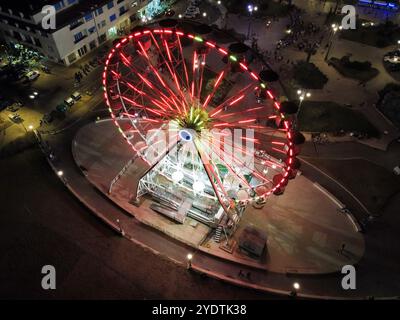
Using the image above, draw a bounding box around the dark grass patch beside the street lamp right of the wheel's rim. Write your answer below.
[298,101,379,137]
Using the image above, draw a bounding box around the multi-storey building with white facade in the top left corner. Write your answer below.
[0,0,150,65]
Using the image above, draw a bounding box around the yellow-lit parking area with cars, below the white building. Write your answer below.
[0,42,107,146]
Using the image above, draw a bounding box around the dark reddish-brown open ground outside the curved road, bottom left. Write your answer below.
[0,149,272,299]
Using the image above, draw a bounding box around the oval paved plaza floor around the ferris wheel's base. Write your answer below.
[73,120,364,274]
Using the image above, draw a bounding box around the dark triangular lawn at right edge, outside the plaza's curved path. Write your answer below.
[307,159,400,214]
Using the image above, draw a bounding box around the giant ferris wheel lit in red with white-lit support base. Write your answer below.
[103,20,304,226]
